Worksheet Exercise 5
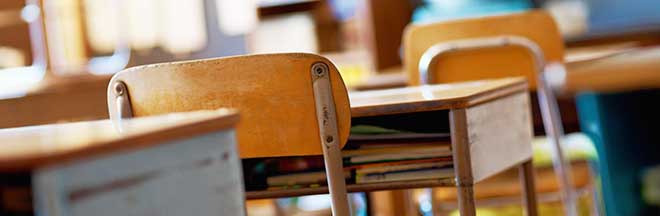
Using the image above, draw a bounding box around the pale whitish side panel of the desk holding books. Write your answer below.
[466,92,533,182]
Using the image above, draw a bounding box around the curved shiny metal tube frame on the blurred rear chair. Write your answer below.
[419,36,577,215]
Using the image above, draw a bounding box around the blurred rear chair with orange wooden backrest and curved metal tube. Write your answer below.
[403,11,576,215]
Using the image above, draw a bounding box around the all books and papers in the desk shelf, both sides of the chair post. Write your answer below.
[244,125,453,190]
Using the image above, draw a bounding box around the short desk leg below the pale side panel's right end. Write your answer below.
[518,160,538,216]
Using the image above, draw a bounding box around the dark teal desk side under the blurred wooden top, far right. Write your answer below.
[576,90,660,216]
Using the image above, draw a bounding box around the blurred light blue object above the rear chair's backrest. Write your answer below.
[412,0,534,23]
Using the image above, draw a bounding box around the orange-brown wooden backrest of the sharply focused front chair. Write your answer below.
[108,53,350,158]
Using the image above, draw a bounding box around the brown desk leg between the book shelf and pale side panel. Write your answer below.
[449,109,476,216]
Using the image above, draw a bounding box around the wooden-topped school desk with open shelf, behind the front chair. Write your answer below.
[246,78,536,215]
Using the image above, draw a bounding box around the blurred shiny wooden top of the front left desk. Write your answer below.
[0,109,238,172]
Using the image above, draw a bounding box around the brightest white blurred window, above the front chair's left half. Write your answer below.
[84,0,207,54]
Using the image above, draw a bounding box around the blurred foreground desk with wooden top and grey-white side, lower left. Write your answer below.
[0,110,244,216]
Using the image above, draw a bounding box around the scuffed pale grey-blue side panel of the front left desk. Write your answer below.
[33,130,245,216]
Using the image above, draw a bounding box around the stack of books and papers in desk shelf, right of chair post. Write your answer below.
[342,125,453,184]
